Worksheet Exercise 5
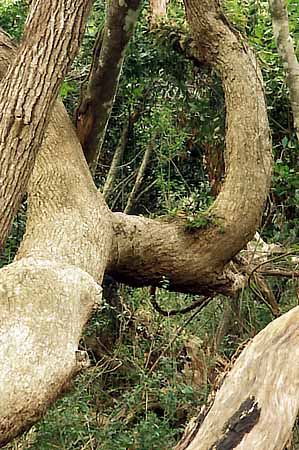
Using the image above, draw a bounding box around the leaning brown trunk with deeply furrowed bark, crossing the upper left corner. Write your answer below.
[0,0,91,248]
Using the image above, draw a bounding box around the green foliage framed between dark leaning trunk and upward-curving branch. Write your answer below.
[99,3,224,215]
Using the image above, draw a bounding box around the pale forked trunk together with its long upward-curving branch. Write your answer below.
[0,0,276,444]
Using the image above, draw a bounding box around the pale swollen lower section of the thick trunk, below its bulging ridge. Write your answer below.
[0,258,101,446]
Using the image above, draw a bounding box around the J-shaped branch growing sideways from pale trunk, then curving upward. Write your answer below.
[107,0,272,293]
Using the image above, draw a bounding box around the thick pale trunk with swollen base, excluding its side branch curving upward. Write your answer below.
[0,28,111,445]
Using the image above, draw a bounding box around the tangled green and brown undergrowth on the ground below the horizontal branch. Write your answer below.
[5,282,298,450]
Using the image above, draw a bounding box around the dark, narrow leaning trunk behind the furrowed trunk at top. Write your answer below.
[76,0,141,173]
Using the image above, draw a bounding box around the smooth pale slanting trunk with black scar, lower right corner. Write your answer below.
[176,307,299,450]
